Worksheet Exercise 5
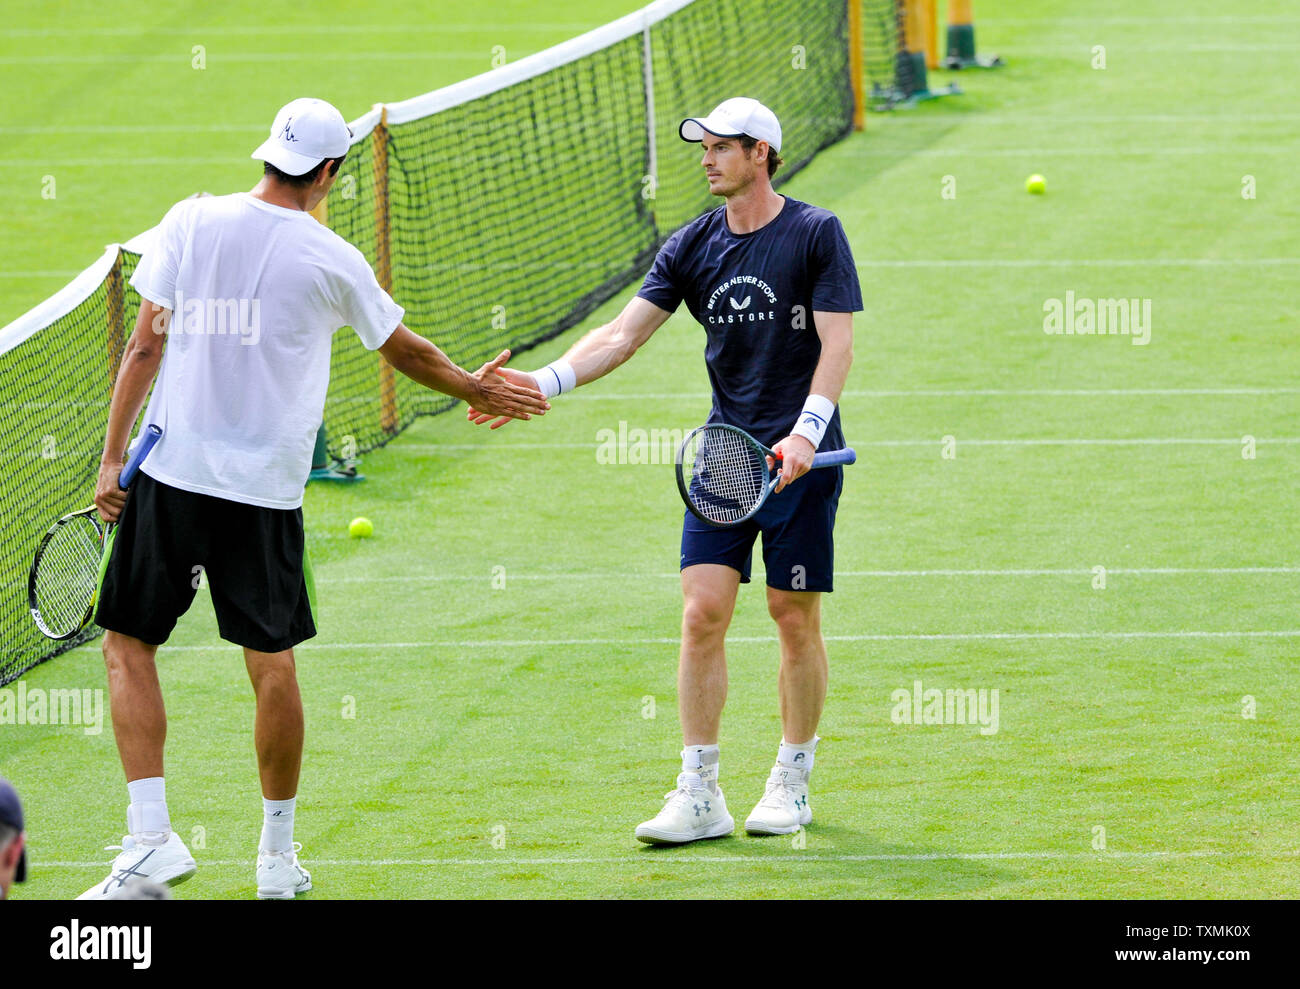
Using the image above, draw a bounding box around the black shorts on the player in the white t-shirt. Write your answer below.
[95,470,316,652]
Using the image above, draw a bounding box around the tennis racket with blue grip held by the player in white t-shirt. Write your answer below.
[27,425,163,639]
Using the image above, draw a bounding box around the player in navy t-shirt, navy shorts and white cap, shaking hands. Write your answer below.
[469,97,862,845]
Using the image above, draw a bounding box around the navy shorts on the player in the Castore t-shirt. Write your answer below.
[681,467,844,591]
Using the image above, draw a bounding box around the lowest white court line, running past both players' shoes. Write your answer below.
[40,849,1300,869]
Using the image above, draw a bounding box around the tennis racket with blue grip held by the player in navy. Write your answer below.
[677,422,858,528]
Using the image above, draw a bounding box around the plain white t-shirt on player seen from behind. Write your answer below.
[131,192,403,508]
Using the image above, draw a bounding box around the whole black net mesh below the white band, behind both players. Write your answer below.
[0,0,873,684]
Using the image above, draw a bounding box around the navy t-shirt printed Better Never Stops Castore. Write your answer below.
[637,196,862,450]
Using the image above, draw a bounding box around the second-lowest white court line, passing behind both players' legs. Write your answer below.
[154,629,1300,652]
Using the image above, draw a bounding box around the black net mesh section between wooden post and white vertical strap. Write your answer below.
[389,31,655,447]
